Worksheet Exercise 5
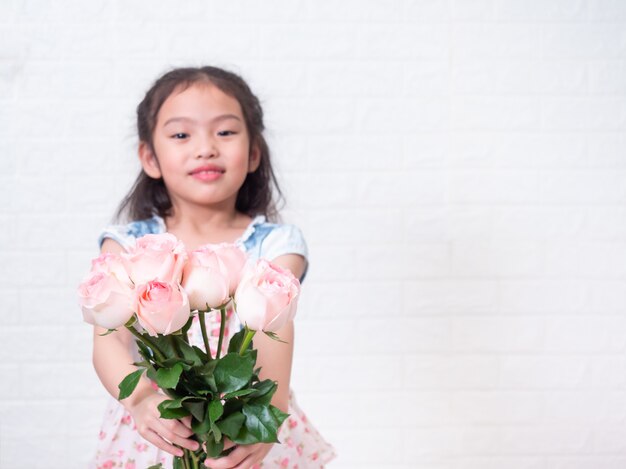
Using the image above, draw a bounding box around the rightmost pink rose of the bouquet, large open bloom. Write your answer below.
[235,259,300,332]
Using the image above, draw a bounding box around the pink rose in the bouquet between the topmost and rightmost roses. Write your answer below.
[183,243,246,310]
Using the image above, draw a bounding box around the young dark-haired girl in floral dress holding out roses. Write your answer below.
[92,67,334,469]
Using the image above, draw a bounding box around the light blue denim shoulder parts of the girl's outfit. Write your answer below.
[98,215,309,282]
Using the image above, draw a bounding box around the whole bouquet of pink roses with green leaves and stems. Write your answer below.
[78,233,300,469]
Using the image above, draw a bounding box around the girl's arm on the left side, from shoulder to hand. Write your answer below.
[93,239,198,456]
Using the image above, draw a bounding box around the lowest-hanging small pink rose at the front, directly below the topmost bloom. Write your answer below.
[135,280,191,336]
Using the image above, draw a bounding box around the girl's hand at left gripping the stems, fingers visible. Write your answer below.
[127,392,200,456]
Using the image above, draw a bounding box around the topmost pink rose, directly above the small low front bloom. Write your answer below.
[122,233,187,285]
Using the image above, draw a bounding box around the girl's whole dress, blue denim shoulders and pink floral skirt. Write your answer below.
[89,215,335,469]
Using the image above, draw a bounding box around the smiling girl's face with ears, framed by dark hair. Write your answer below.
[139,83,260,214]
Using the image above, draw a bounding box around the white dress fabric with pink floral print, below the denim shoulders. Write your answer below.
[89,309,335,469]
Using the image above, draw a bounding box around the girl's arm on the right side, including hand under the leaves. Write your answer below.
[205,254,306,469]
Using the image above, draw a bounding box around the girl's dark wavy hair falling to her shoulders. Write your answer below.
[115,66,284,222]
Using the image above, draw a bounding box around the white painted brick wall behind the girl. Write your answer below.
[0,0,626,469]
